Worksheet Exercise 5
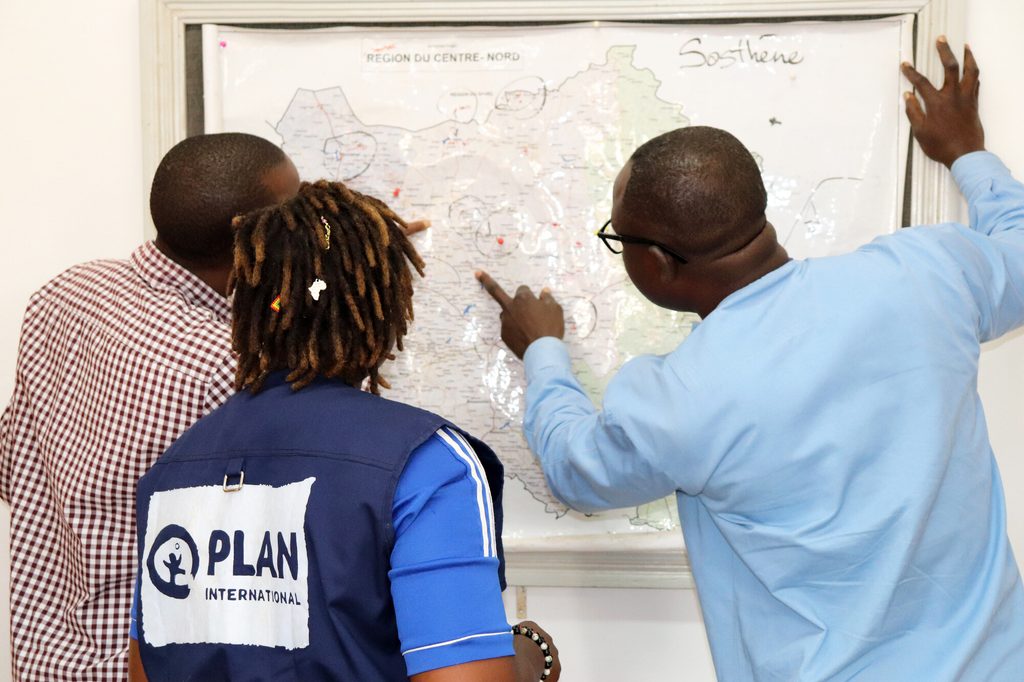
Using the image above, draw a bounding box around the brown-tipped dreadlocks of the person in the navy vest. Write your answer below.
[228,180,423,393]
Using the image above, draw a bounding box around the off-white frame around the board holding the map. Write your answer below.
[139,0,966,588]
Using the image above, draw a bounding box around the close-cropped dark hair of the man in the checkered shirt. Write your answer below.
[150,133,288,264]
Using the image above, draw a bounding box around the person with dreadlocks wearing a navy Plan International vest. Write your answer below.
[125,180,560,682]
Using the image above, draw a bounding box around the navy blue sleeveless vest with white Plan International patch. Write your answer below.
[136,373,505,682]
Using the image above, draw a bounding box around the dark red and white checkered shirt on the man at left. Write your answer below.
[0,243,234,682]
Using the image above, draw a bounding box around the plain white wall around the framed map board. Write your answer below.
[0,0,1024,682]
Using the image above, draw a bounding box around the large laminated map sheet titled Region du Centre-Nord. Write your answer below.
[204,22,904,537]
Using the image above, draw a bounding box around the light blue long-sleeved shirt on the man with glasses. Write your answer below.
[524,153,1024,682]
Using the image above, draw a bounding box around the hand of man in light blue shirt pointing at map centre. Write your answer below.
[476,270,565,359]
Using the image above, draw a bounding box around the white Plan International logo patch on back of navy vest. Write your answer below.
[140,478,315,649]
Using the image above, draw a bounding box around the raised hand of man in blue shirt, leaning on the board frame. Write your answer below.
[902,37,985,167]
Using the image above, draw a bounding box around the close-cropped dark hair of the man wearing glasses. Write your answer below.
[623,126,768,256]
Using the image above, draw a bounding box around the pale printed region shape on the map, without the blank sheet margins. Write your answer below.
[275,46,686,527]
